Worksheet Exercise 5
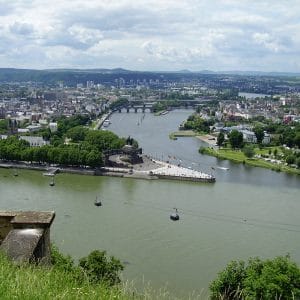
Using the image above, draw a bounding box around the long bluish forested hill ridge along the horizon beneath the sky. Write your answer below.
[0,68,300,86]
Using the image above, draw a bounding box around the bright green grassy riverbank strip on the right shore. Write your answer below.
[199,147,300,175]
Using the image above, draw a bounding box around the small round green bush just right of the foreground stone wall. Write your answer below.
[79,250,124,286]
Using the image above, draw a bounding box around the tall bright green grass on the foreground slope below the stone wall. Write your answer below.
[0,253,192,300]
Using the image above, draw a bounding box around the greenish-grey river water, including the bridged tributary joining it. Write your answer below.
[0,110,300,299]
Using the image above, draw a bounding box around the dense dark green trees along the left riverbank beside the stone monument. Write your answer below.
[0,116,126,167]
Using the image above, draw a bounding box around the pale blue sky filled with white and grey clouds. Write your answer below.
[0,0,300,72]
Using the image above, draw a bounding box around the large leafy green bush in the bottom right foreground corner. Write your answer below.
[210,256,300,300]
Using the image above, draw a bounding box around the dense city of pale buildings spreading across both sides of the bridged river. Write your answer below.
[0,70,300,173]
